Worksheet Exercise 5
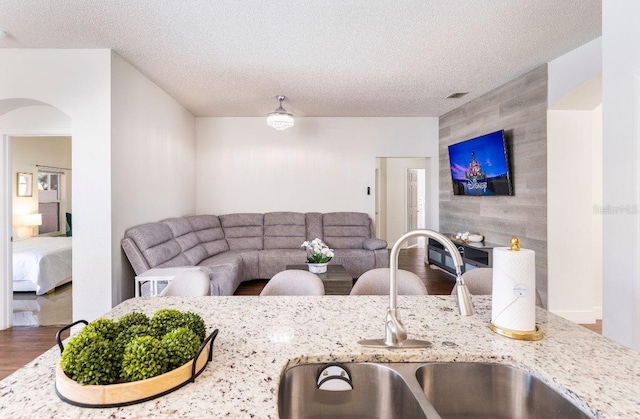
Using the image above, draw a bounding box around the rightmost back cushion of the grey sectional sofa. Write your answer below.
[322,212,371,249]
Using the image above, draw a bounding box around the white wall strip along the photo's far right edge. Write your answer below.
[602,0,640,350]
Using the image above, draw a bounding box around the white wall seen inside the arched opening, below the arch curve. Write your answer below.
[547,108,602,323]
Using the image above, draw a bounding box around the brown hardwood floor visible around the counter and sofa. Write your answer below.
[0,248,602,380]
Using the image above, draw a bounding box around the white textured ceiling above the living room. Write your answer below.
[0,0,602,116]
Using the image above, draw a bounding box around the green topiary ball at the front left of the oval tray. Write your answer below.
[60,328,120,384]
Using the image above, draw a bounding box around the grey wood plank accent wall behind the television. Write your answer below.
[439,64,547,307]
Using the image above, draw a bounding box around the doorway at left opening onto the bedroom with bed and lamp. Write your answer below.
[9,135,73,326]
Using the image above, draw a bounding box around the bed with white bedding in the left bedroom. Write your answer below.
[13,237,71,295]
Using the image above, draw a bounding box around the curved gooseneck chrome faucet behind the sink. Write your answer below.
[358,230,473,348]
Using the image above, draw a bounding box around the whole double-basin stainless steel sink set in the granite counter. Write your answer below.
[278,363,590,419]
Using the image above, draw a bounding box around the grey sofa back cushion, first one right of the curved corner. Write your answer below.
[220,214,264,250]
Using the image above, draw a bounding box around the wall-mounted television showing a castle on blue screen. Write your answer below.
[449,130,513,196]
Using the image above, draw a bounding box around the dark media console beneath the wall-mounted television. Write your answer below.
[427,239,503,275]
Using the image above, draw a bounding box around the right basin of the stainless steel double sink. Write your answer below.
[416,362,589,419]
